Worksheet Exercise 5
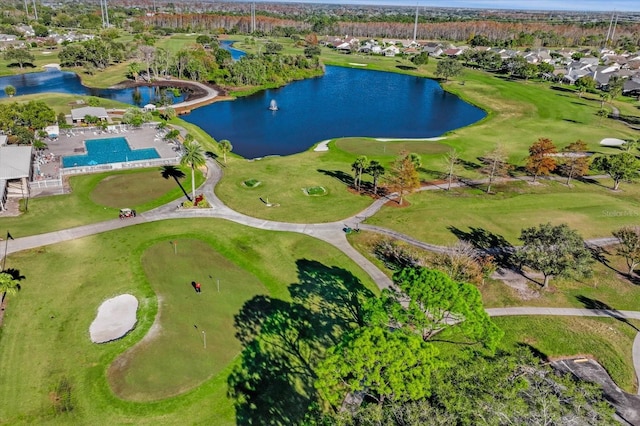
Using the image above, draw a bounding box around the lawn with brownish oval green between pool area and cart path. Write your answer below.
[0,169,204,238]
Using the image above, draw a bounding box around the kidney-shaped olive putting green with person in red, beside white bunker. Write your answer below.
[109,239,267,401]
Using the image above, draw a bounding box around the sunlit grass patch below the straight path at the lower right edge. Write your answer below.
[493,316,640,394]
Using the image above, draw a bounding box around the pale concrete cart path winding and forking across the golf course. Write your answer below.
[2,158,640,394]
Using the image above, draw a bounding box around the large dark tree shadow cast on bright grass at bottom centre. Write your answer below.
[227,259,373,425]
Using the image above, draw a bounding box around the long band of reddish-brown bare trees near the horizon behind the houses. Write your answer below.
[145,13,640,50]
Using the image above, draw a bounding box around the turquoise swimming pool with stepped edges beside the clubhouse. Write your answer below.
[62,137,160,168]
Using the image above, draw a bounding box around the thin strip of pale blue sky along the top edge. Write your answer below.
[252,0,640,12]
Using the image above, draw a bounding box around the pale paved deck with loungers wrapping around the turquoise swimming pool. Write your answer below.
[40,127,177,179]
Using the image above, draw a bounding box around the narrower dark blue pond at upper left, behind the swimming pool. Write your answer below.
[0,69,185,106]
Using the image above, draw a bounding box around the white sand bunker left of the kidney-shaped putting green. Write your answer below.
[89,294,138,343]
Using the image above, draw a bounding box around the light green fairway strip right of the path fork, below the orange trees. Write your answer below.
[367,180,640,244]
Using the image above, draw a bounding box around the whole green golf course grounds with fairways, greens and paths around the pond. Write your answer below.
[0,31,640,425]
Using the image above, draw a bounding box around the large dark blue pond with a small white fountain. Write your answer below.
[182,66,486,158]
